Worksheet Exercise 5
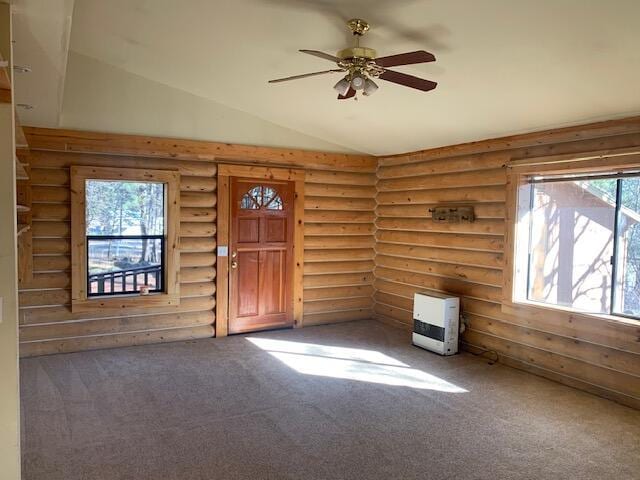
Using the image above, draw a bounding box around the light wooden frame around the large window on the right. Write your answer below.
[502,148,640,325]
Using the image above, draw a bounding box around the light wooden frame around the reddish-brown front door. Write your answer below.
[215,164,305,337]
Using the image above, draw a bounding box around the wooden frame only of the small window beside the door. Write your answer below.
[70,166,180,313]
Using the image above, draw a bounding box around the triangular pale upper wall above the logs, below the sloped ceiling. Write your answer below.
[61,51,360,152]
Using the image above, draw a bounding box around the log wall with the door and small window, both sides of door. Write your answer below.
[19,133,376,356]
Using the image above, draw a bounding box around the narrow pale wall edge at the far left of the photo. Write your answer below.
[0,2,20,480]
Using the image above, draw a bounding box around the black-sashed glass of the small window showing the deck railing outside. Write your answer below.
[85,179,166,297]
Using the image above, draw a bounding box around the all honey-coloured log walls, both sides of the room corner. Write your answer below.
[20,118,640,408]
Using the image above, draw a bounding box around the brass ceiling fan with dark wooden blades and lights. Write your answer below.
[269,18,437,100]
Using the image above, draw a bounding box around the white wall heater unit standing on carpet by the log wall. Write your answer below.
[412,293,460,355]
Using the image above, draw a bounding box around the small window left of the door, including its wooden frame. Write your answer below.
[71,166,180,311]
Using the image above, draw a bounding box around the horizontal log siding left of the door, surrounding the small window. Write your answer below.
[19,151,217,356]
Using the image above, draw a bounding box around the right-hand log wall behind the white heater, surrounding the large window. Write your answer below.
[374,119,640,407]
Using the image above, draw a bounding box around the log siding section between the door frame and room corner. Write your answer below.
[304,168,376,326]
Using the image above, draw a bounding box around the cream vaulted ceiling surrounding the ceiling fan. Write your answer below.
[11,0,640,154]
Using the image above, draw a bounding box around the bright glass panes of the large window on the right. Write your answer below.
[518,174,640,318]
